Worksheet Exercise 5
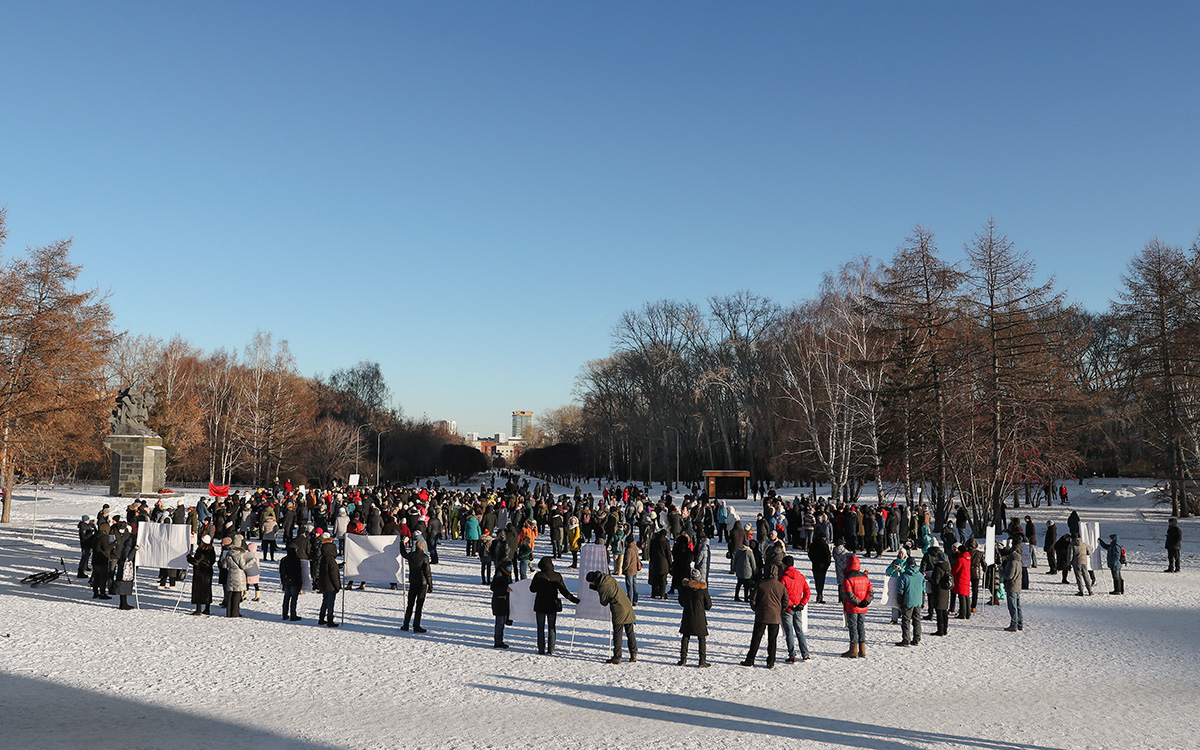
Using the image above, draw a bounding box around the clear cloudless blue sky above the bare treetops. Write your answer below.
[0,1,1200,433]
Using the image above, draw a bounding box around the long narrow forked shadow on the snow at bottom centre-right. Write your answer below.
[473,674,1070,750]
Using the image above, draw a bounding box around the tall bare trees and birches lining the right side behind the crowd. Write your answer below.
[561,222,1200,520]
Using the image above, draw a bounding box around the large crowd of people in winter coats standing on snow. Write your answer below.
[70,473,1182,667]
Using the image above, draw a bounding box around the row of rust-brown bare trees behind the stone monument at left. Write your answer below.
[0,209,486,522]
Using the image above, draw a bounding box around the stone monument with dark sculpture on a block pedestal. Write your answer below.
[104,388,167,497]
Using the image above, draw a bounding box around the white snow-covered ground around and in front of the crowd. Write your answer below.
[0,480,1200,750]
